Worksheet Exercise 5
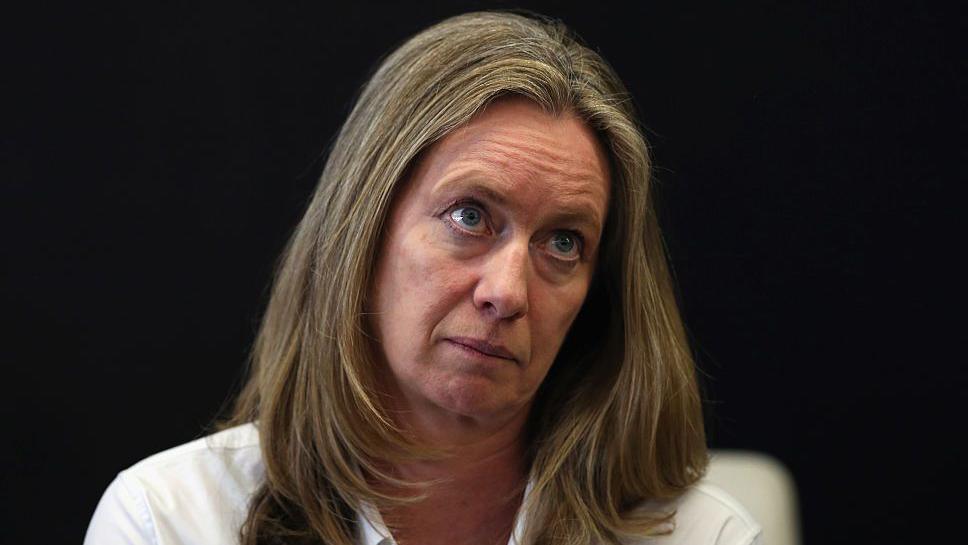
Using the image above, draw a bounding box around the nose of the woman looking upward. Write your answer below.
[474,241,530,320]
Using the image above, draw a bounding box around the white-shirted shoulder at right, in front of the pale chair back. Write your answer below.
[630,481,762,545]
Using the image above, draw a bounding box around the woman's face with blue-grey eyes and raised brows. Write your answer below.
[369,98,609,430]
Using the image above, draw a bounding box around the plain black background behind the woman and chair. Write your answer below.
[0,2,968,544]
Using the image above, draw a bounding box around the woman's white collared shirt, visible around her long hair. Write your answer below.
[84,424,760,545]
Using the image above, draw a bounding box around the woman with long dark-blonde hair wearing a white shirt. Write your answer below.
[87,8,759,545]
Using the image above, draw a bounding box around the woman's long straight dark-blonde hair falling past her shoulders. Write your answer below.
[224,12,707,545]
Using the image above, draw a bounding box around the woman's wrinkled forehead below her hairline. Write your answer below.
[414,98,609,227]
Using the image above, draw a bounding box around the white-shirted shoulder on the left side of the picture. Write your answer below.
[85,424,265,545]
